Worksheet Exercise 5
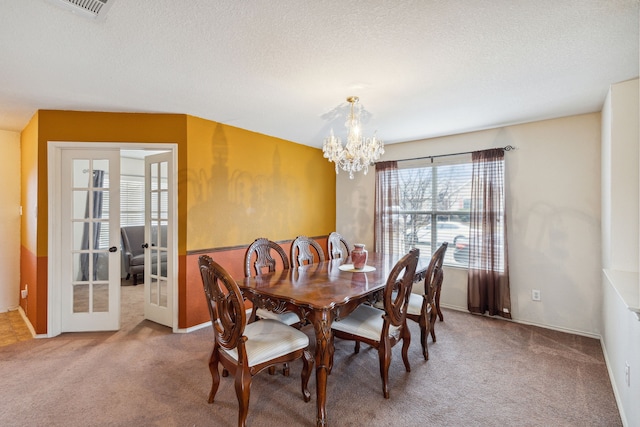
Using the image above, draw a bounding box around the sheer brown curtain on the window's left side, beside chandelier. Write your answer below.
[373,161,400,254]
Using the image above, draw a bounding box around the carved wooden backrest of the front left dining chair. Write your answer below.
[198,255,246,352]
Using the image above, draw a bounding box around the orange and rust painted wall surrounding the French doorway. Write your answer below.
[21,110,336,334]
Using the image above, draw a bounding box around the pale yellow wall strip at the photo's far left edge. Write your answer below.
[0,130,20,312]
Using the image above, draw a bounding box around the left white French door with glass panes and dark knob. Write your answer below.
[58,149,121,332]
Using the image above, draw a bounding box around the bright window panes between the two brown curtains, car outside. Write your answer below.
[393,155,472,267]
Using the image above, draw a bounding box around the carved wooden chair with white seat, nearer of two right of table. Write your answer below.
[332,248,420,399]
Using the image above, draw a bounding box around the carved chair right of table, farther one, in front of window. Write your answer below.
[407,242,448,360]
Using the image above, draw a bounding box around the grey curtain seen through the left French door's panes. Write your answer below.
[80,169,104,281]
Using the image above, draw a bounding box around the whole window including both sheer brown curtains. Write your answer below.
[374,150,513,318]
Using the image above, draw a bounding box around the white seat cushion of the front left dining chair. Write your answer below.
[222,319,309,366]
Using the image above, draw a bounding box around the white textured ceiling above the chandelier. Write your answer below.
[0,0,639,147]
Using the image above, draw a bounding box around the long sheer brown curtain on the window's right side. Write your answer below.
[467,148,511,319]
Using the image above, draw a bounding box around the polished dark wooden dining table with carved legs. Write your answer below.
[238,252,429,426]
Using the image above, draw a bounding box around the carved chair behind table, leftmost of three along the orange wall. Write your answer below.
[244,237,302,328]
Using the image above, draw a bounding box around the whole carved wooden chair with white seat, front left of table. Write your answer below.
[198,255,314,426]
